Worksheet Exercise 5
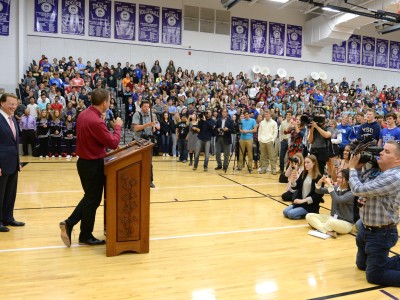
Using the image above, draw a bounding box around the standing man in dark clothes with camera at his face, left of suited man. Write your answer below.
[193,109,215,172]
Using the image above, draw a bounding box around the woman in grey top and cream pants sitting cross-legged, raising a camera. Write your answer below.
[306,169,355,238]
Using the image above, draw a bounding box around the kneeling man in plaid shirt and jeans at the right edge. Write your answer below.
[349,141,400,287]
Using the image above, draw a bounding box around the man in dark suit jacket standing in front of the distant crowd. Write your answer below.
[215,108,235,171]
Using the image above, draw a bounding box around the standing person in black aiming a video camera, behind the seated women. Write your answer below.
[308,114,332,174]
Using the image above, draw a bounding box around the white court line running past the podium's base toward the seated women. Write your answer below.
[0,224,309,253]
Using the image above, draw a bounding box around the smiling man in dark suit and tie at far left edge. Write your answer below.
[0,94,25,232]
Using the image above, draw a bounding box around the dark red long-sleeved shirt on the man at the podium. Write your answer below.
[76,106,121,160]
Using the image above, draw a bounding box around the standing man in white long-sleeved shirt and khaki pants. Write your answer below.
[258,109,278,175]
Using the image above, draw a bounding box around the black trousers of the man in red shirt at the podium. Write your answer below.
[67,158,105,241]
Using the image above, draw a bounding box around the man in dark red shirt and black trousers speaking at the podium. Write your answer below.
[60,89,123,247]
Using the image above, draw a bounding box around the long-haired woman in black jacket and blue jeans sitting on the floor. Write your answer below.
[283,155,324,220]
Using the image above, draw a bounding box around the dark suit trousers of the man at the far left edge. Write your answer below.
[0,171,18,224]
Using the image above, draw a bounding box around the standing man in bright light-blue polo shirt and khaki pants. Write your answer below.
[237,111,257,171]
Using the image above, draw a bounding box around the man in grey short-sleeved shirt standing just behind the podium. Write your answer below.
[132,100,160,188]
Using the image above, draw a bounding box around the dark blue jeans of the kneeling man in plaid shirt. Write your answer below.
[356,220,400,287]
